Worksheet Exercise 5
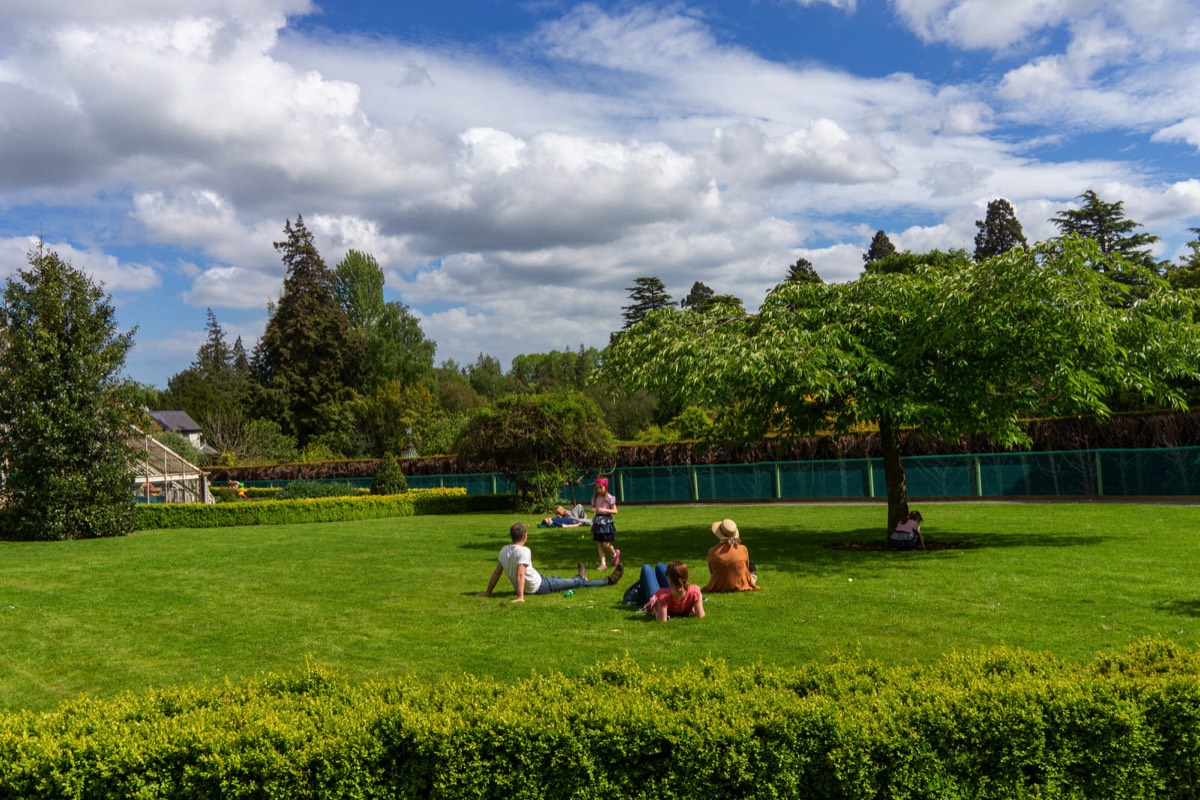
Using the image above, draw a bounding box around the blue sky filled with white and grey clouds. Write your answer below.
[0,0,1200,386]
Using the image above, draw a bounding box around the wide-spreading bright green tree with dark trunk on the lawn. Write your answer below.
[604,237,1200,529]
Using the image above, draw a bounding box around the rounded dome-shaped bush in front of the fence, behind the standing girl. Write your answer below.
[457,392,616,509]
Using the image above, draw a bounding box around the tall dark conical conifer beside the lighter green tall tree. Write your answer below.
[254,216,361,446]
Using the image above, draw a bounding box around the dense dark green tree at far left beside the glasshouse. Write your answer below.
[0,248,133,540]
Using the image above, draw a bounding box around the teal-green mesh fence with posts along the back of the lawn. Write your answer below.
[247,447,1200,503]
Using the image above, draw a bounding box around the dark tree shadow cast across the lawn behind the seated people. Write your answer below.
[460,525,1108,583]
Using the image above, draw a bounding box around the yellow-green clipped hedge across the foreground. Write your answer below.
[0,640,1200,800]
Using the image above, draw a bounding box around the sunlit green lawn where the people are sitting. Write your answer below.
[0,504,1200,710]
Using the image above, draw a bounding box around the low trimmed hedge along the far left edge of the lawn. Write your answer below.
[134,488,512,530]
